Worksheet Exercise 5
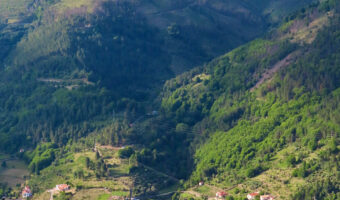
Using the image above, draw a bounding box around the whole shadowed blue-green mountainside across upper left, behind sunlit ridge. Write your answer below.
[0,0,311,151]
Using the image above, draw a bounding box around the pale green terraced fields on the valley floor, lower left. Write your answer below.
[30,150,131,200]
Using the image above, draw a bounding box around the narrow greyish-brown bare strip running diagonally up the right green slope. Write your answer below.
[250,51,300,92]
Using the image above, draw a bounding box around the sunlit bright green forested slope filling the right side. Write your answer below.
[156,1,340,199]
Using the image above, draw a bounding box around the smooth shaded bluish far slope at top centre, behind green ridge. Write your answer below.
[133,0,313,74]
